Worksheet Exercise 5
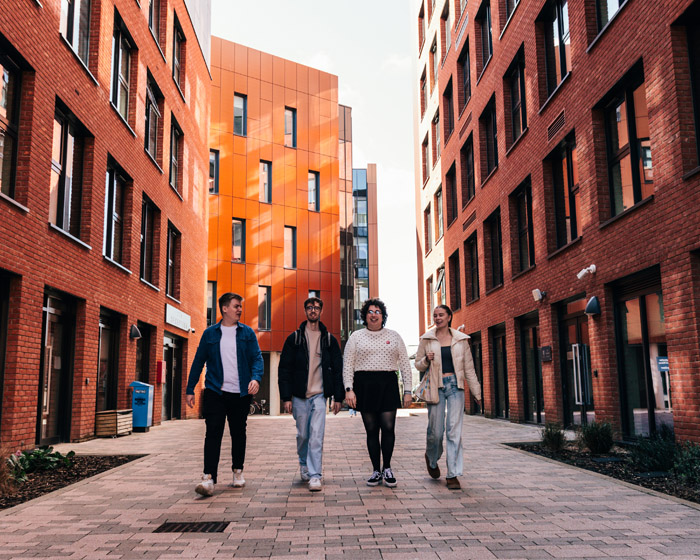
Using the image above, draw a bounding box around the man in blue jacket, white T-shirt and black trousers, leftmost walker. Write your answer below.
[185,292,263,496]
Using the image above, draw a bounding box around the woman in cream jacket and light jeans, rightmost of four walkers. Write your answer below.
[416,305,481,490]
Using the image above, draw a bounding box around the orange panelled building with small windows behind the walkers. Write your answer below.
[207,37,340,414]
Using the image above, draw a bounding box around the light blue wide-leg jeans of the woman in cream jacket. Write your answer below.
[425,375,464,478]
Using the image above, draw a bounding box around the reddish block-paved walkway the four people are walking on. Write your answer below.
[0,411,700,560]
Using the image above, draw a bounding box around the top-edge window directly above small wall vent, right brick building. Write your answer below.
[541,0,571,95]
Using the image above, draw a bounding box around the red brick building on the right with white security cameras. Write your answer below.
[416,0,700,441]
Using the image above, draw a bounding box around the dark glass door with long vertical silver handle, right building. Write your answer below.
[559,298,595,426]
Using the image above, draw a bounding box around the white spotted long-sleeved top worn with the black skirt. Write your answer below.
[343,329,413,393]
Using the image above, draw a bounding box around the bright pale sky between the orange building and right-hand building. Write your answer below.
[211,0,418,345]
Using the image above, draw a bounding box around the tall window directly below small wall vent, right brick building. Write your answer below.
[549,133,581,248]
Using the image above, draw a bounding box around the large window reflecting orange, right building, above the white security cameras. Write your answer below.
[605,71,654,216]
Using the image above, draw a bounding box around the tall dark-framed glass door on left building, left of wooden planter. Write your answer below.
[36,295,73,445]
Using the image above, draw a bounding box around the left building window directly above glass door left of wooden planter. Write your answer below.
[49,108,85,238]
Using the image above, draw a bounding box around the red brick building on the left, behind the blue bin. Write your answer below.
[0,0,210,447]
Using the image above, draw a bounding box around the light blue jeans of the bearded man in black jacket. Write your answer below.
[292,393,326,478]
